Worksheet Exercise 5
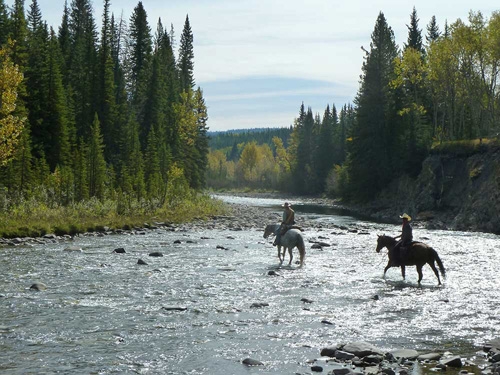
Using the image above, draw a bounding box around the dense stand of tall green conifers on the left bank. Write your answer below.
[0,0,217,235]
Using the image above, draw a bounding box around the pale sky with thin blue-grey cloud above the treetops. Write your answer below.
[20,0,500,131]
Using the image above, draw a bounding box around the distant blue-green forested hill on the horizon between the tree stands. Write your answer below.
[207,127,293,150]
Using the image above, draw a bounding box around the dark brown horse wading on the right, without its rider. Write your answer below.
[376,236,445,285]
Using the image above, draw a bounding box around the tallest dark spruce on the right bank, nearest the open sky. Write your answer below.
[348,12,398,200]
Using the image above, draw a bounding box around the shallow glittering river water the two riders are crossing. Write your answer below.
[0,197,500,374]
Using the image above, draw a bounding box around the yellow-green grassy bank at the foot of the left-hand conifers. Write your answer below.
[0,194,227,238]
